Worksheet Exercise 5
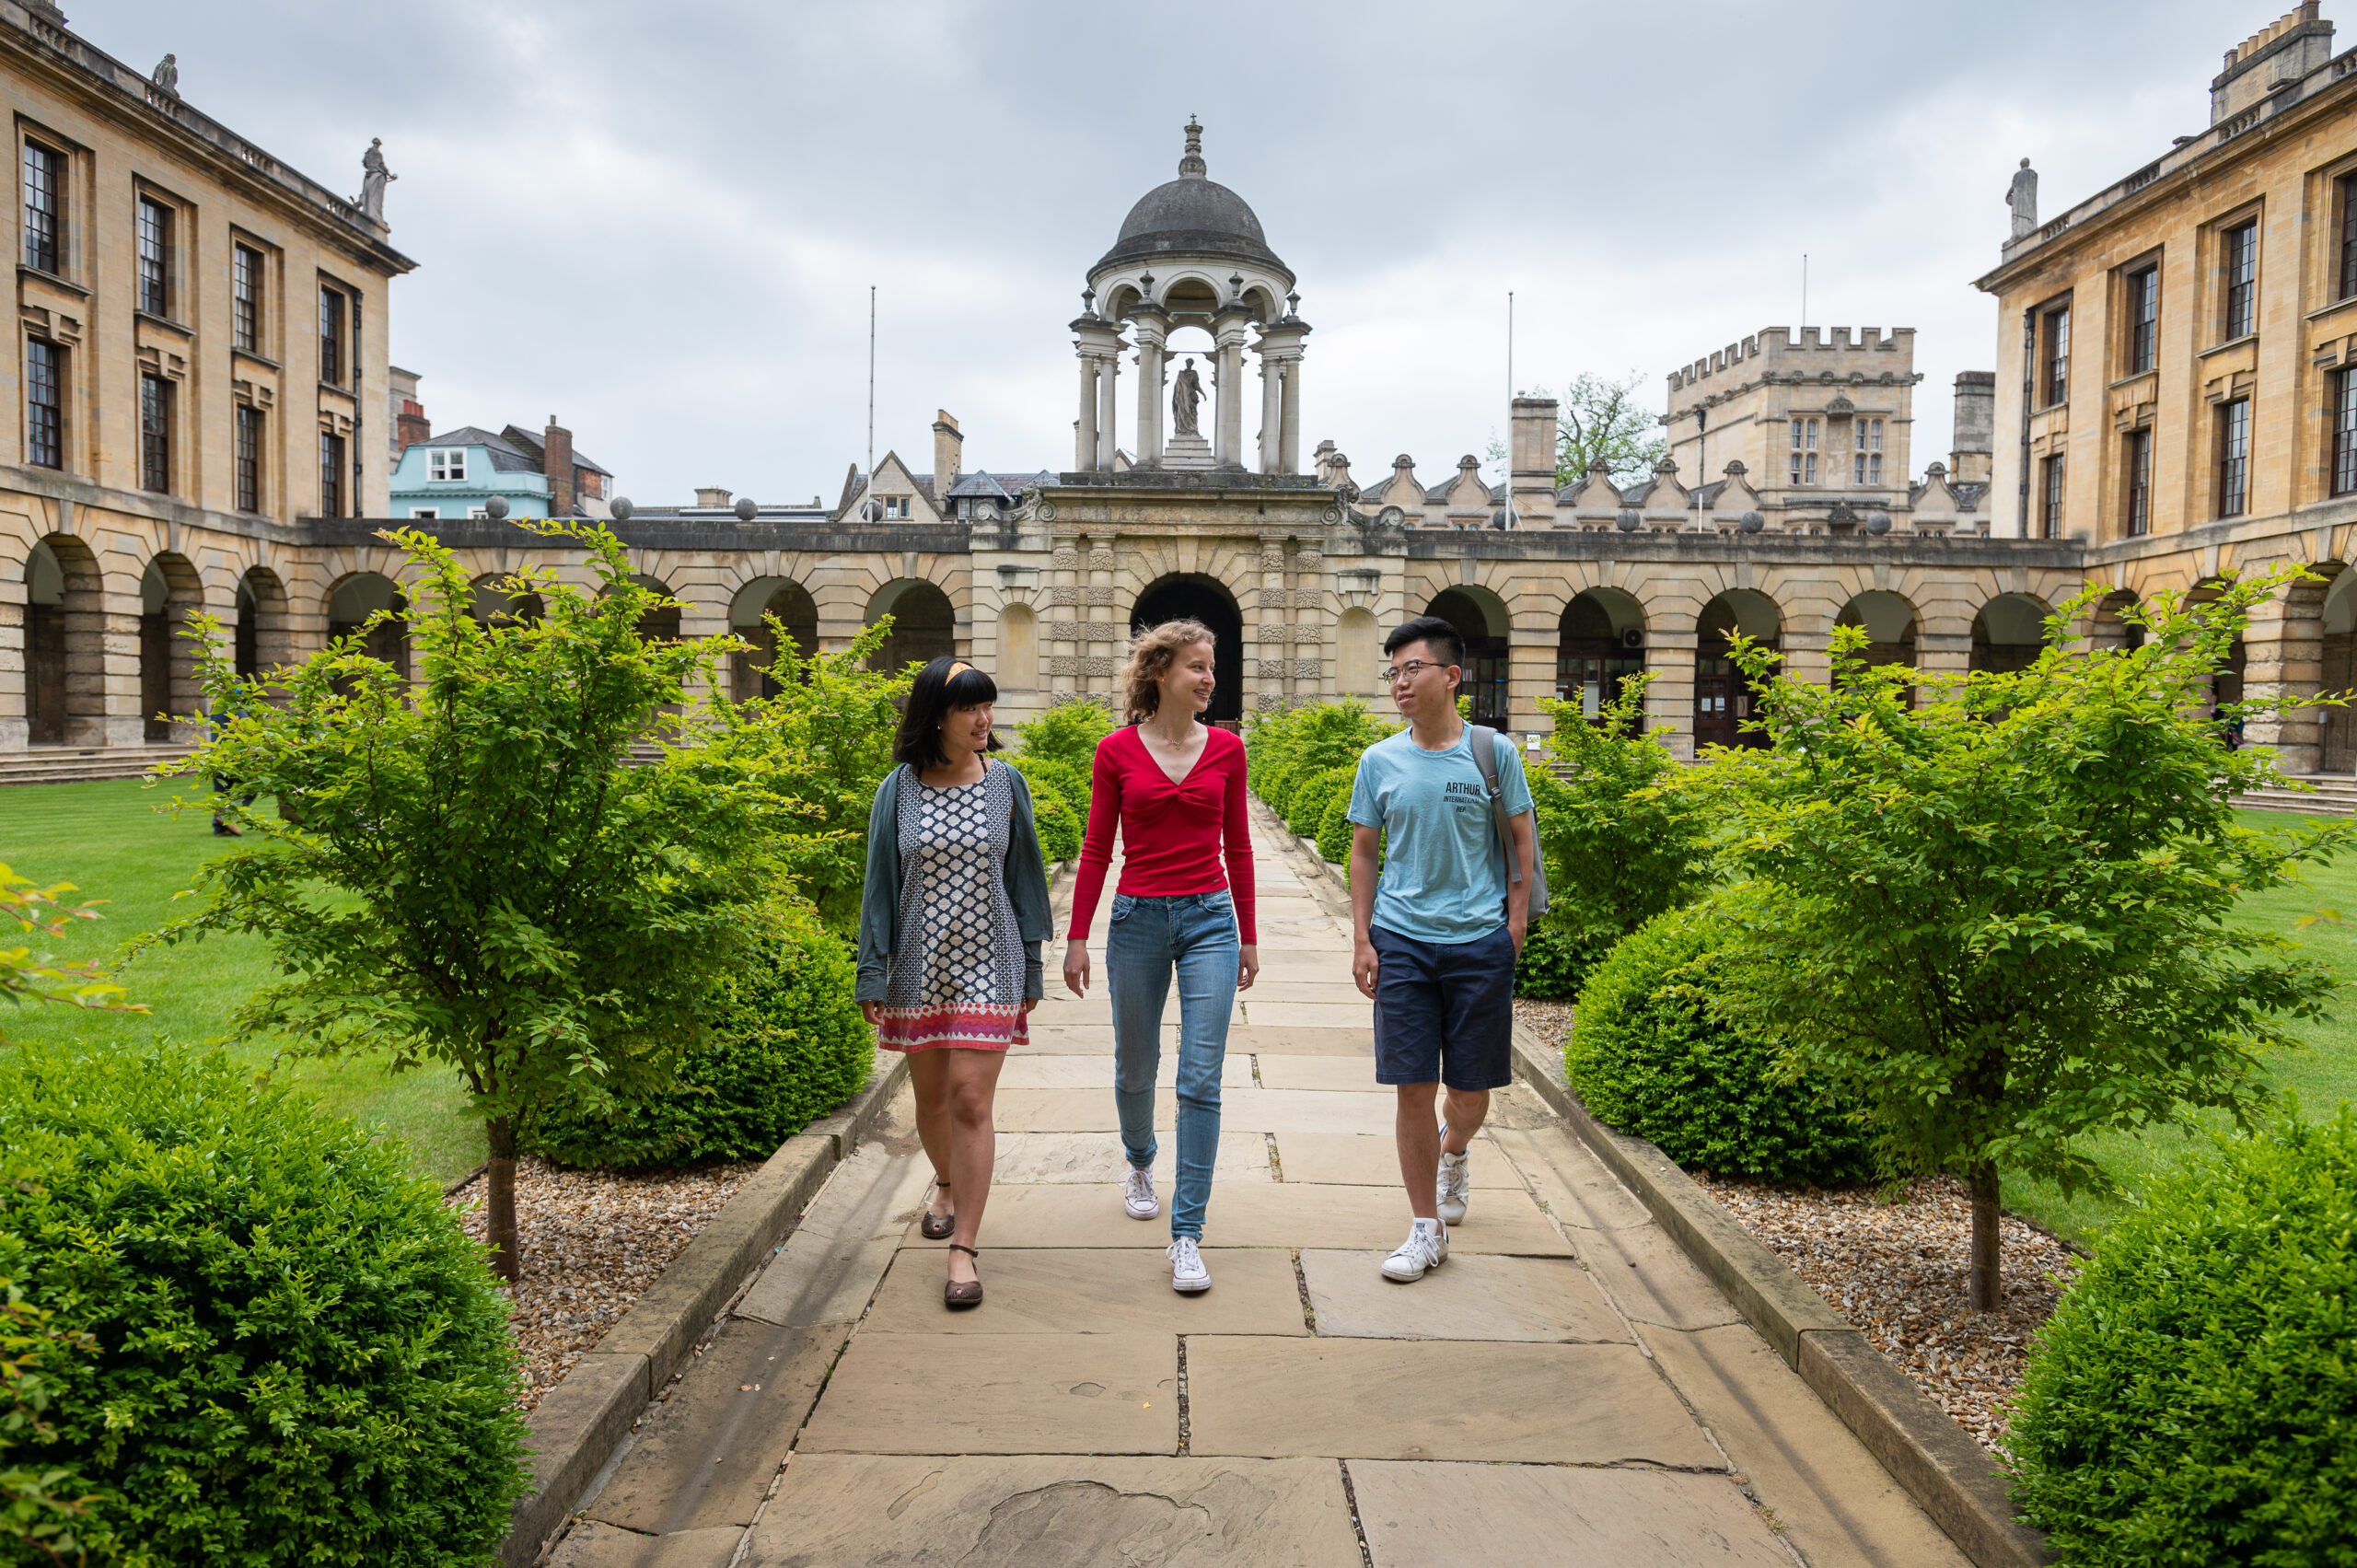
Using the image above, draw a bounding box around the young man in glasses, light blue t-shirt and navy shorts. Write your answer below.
[1351,615,1535,1281]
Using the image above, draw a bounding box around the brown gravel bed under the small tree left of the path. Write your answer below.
[447,1160,761,1410]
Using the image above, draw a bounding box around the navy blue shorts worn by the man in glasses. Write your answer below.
[1367,926,1514,1094]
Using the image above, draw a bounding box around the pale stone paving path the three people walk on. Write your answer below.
[554,807,1966,1568]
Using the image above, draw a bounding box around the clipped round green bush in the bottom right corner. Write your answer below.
[2008,1104,2357,1568]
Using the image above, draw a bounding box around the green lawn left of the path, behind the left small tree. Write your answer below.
[0,781,483,1181]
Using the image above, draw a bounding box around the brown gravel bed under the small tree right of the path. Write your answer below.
[1688,1172,2079,1455]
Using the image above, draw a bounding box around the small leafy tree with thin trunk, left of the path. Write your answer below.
[146,521,795,1281]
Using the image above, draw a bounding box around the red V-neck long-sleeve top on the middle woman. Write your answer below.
[1070,724,1259,943]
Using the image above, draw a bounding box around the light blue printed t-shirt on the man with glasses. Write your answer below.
[1351,724,1529,943]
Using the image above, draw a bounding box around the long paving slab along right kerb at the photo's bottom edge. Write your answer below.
[1645,1323,1968,1568]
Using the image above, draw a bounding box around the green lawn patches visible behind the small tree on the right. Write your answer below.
[2006,811,2357,1240]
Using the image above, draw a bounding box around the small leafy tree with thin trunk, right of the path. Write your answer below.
[1706,573,2350,1308]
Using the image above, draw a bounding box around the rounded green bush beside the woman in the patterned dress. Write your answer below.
[526,905,875,1169]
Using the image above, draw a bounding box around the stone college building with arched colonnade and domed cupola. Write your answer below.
[0,0,2357,776]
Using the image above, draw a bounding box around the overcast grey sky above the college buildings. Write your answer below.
[83,0,2286,502]
